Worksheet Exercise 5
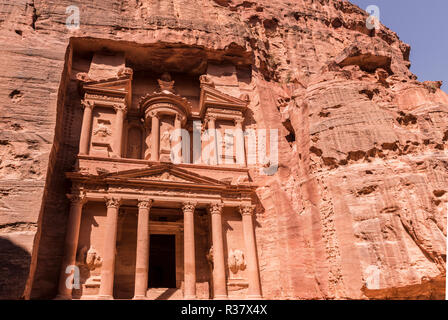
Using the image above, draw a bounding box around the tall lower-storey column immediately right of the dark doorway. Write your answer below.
[182,202,196,299]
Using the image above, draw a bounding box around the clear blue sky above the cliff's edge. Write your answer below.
[350,0,448,92]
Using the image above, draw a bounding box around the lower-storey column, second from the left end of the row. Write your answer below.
[98,198,121,299]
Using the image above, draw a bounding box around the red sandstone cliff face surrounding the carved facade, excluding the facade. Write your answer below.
[0,0,448,299]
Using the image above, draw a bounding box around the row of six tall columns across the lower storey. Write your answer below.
[57,193,262,299]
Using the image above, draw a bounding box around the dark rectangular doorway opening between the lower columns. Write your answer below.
[148,234,176,288]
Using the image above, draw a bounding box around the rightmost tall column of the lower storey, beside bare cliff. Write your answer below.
[240,206,261,299]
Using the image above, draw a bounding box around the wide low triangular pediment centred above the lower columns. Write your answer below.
[106,164,229,186]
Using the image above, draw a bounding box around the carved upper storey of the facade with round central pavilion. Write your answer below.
[76,53,254,178]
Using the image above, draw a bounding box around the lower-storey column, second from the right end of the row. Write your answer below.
[210,203,227,299]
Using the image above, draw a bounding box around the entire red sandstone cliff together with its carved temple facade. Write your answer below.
[0,0,448,299]
